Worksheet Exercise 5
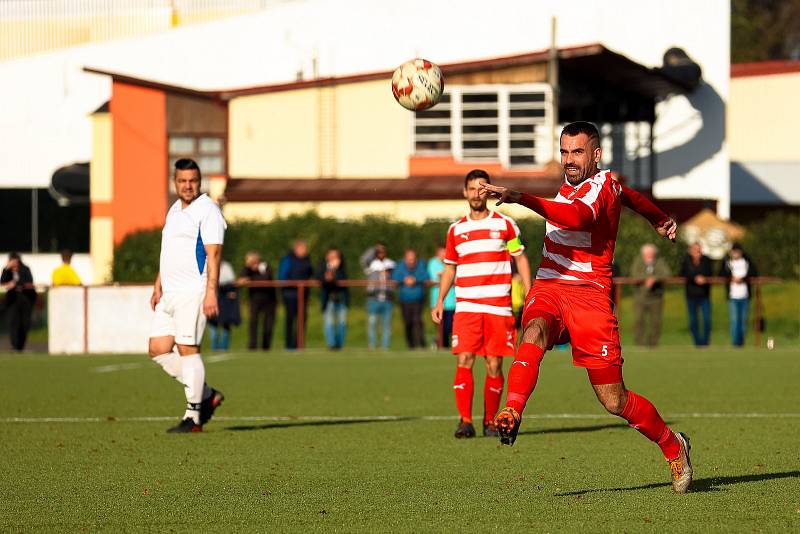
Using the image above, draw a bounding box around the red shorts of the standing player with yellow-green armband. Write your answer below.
[450,312,517,356]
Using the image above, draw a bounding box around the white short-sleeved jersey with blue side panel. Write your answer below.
[160,194,228,292]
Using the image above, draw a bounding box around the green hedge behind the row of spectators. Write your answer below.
[113,210,800,282]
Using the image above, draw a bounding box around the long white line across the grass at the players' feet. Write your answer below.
[0,412,800,424]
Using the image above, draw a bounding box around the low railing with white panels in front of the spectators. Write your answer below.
[47,277,782,354]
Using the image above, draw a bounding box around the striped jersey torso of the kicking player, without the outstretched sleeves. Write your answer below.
[536,171,622,290]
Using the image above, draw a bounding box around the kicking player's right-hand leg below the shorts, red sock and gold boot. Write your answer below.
[587,372,692,493]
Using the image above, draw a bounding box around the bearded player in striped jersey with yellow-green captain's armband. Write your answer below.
[431,169,531,438]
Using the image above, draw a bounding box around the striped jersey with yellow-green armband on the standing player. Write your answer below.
[444,211,525,316]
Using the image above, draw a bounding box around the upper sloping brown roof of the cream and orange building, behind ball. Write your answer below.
[84,43,691,100]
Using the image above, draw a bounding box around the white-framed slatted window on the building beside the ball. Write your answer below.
[414,84,553,167]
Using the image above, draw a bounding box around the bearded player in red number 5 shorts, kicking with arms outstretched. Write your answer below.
[481,122,692,493]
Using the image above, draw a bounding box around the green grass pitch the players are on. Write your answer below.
[0,348,800,532]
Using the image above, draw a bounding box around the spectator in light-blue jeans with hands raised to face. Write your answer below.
[360,242,397,349]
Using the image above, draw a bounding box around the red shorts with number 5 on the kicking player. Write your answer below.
[522,280,622,369]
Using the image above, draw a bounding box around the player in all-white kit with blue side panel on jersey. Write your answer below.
[149,158,227,433]
